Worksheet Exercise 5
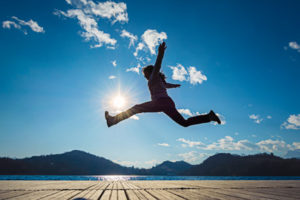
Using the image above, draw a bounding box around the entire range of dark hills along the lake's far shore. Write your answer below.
[0,150,300,176]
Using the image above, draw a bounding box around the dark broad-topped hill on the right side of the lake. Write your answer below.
[180,153,300,176]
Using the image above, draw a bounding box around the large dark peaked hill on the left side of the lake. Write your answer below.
[0,150,143,175]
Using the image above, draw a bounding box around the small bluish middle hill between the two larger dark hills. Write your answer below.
[148,161,193,175]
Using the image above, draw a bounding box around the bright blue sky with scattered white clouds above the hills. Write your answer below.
[0,0,300,168]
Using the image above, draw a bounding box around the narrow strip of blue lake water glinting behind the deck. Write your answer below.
[0,175,300,181]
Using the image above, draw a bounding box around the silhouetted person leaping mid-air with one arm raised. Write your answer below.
[105,42,221,127]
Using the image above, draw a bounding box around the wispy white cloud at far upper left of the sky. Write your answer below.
[2,16,45,35]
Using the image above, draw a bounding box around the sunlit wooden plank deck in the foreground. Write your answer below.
[0,181,300,200]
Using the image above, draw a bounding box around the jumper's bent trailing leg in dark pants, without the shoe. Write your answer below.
[164,107,211,127]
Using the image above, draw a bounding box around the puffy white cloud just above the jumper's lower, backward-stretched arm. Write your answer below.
[169,63,207,85]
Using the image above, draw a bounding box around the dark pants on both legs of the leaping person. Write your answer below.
[114,97,211,127]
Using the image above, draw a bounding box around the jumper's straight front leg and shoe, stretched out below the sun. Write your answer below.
[105,101,162,127]
